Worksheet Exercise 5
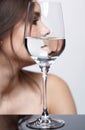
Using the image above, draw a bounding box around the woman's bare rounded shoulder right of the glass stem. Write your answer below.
[47,74,76,114]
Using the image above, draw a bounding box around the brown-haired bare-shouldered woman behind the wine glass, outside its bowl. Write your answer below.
[0,0,76,114]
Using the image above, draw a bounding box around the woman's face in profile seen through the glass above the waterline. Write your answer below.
[30,2,50,38]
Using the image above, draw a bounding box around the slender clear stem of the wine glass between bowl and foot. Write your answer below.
[40,66,50,117]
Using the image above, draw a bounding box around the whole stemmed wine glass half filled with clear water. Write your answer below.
[18,0,65,129]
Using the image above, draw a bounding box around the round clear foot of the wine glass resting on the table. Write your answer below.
[18,116,65,130]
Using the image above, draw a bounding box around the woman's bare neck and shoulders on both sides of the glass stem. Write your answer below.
[0,51,76,114]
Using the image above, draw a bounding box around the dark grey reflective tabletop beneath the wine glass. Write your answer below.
[0,115,85,130]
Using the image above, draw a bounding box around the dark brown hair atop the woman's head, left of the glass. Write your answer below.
[0,0,32,40]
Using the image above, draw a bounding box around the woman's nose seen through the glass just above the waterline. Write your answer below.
[39,22,50,37]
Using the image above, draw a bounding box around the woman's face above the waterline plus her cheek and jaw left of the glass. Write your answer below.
[1,1,49,65]
